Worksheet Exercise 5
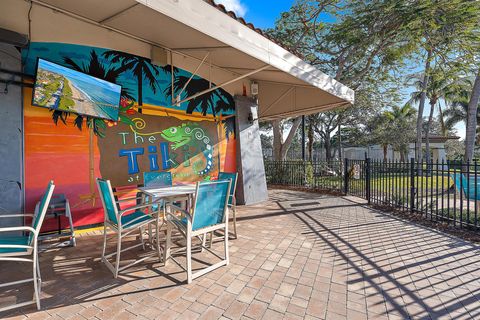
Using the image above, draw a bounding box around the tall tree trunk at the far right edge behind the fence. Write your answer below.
[465,69,480,161]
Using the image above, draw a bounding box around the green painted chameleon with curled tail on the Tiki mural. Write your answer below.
[161,123,213,176]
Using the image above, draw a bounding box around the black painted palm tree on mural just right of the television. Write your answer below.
[103,50,170,106]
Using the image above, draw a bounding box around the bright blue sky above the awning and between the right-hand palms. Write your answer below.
[215,0,465,139]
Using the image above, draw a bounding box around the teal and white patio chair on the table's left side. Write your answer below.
[97,178,162,278]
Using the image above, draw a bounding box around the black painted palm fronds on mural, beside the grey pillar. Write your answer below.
[164,75,235,138]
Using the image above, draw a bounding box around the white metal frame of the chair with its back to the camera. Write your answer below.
[164,182,231,284]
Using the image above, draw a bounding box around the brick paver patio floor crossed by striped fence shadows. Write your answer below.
[0,190,480,320]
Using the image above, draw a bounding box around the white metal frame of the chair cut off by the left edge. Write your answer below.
[0,182,55,312]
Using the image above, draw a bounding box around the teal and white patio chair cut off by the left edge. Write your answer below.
[0,181,55,312]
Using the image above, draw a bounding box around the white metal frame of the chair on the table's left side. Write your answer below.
[97,179,163,278]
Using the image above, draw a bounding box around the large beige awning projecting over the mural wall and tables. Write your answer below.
[6,0,354,120]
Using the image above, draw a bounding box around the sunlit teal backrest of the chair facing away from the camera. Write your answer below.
[192,180,231,231]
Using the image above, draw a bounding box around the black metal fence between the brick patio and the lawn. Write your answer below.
[265,159,480,228]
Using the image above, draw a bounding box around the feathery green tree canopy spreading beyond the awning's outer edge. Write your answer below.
[267,0,480,159]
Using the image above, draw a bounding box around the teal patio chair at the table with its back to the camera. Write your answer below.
[164,181,231,283]
